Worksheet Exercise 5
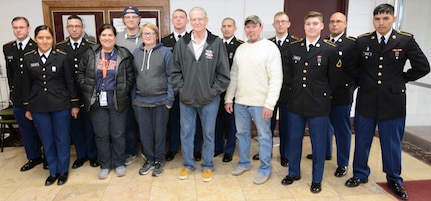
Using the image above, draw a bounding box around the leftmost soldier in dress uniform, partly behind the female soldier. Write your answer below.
[3,16,48,171]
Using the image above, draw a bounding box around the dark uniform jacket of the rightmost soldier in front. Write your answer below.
[346,30,430,120]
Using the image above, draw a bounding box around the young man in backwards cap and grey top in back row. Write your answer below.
[116,6,144,165]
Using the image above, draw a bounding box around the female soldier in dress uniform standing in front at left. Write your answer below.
[23,25,79,186]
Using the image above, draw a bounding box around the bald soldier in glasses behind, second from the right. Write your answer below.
[307,12,356,177]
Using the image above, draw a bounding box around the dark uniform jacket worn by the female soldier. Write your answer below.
[22,50,79,112]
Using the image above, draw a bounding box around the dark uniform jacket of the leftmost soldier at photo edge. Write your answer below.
[3,39,37,107]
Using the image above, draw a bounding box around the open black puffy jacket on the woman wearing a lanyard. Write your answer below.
[76,44,135,112]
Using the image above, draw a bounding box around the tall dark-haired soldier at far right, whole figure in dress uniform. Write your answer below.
[345,4,430,199]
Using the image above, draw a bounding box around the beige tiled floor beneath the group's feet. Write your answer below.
[0,137,431,201]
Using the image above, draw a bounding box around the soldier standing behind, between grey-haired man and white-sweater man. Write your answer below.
[214,17,244,162]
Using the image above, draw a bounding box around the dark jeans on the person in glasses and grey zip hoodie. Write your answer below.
[133,105,169,162]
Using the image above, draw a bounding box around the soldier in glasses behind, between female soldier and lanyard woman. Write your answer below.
[57,15,99,169]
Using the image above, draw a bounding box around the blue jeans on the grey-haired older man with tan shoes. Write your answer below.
[180,96,220,170]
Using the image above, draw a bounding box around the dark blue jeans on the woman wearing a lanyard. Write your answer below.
[90,106,127,169]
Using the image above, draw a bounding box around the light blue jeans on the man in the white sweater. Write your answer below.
[234,103,272,176]
